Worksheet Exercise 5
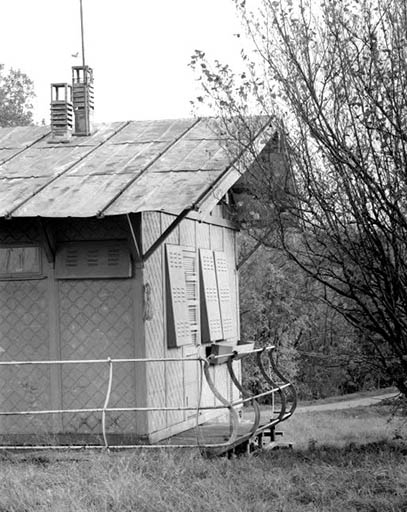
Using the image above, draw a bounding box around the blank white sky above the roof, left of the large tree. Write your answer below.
[0,0,242,124]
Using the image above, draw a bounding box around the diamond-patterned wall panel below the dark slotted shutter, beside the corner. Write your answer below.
[59,279,135,433]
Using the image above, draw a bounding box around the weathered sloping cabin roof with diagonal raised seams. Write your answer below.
[0,119,269,218]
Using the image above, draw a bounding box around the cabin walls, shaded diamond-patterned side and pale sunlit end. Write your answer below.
[0,212,239,442]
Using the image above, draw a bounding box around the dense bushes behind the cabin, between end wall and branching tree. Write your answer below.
[240,233,386,399]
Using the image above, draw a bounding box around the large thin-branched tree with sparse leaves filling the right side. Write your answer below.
[192,0,407,396]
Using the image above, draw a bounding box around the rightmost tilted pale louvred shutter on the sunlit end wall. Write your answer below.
[213,252,236,339]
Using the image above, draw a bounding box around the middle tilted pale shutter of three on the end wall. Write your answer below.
[199,249,223,342]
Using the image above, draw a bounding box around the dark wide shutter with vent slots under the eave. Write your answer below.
[55,241,131,279]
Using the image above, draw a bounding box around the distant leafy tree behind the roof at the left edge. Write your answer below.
[0,64,35,126]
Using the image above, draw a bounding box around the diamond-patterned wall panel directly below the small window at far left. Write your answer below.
[0,280,51,434]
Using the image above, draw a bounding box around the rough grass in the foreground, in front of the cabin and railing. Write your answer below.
[0,406,407,512]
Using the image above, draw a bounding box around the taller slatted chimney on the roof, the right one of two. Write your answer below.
[72,66,94,135]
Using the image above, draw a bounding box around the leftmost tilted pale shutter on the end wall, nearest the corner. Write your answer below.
[166,245,192,347]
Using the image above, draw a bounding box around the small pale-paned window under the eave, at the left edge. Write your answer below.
[0,245,42,279]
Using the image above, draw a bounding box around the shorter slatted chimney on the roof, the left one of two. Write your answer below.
[50,83,73,142]
